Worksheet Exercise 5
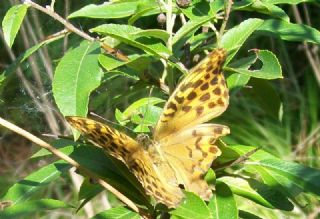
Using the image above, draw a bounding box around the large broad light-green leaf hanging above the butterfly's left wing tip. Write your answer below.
[52,41,102,116]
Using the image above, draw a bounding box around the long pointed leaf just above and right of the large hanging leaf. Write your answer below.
[90,24,171,59]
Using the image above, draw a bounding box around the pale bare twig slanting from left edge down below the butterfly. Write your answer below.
[0,117,150,218]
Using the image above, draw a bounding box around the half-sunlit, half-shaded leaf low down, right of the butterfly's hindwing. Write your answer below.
[218,176,294,211]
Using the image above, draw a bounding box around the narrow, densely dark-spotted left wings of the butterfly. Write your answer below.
[66,116,183,207]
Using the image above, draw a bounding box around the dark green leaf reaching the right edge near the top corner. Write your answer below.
[256,19,320,44]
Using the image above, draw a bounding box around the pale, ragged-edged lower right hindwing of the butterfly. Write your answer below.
[159,124,230,200]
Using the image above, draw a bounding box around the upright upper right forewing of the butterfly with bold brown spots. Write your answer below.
[154,49,229,140]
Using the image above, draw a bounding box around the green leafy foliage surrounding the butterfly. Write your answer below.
[0,0,320,218]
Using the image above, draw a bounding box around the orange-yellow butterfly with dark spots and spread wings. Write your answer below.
[66,48,230,208]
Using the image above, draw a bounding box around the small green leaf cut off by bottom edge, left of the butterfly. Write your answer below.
[91,207,141,219]
